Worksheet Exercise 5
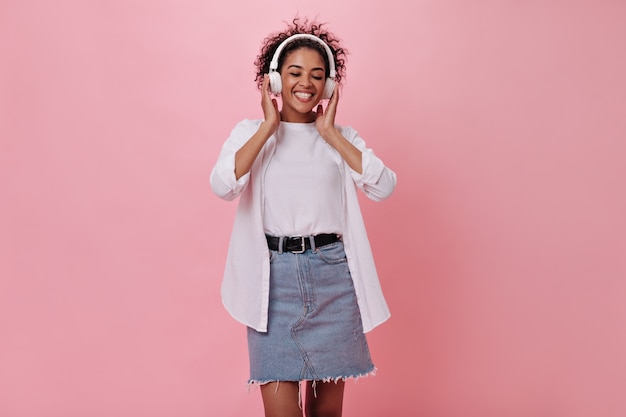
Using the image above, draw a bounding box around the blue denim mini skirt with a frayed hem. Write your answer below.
[247,242,375,384]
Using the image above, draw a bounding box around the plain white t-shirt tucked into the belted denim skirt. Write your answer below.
[263,122,342,236]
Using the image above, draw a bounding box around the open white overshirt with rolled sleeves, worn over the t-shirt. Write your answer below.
[210,119,396,332]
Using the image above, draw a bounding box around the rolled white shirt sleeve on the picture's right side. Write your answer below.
[343,127,397,201]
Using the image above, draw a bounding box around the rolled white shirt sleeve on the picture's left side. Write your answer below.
[210,120,258,200]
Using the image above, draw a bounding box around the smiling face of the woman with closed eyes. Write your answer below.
[280,47,326,123]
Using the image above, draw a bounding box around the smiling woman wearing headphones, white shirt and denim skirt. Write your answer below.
[211,19,396,417]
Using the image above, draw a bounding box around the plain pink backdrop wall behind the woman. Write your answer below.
[0,0,626,417]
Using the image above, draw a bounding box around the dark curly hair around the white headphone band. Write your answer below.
[254,17,348,89]
